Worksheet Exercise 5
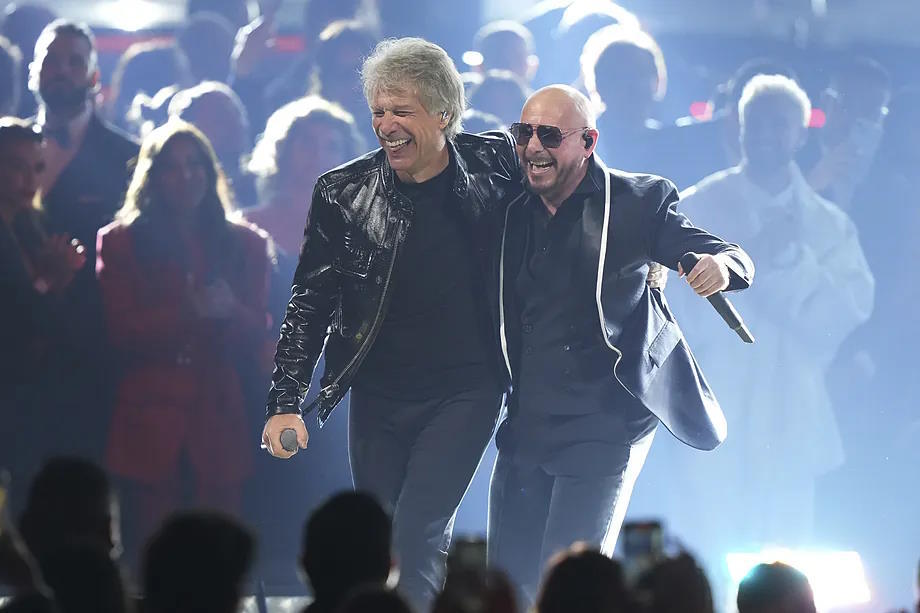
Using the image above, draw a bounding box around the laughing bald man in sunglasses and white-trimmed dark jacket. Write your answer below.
[489,86,754,602]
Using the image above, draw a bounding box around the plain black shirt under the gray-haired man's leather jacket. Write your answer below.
[354,159,501,400]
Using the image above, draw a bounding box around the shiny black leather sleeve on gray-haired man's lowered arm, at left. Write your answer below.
[266,182,340,419]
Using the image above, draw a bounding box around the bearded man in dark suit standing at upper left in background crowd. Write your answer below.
[29,19,138,459]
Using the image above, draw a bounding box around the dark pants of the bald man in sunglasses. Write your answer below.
[489,417,657,610]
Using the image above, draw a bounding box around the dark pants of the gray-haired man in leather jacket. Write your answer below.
[348,388,502,611]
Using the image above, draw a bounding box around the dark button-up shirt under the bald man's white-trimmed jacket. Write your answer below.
[497,159,657,474]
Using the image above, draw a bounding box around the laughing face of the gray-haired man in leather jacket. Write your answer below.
[371,92,450,182]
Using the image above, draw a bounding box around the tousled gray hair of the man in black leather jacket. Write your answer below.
[361,38,466,140]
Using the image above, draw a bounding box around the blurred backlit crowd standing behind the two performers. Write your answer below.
[0,0,920,611]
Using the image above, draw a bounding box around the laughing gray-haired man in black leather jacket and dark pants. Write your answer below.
[263,38,522,611]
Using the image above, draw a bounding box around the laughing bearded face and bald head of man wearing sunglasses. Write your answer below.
[517,89,597,205]
